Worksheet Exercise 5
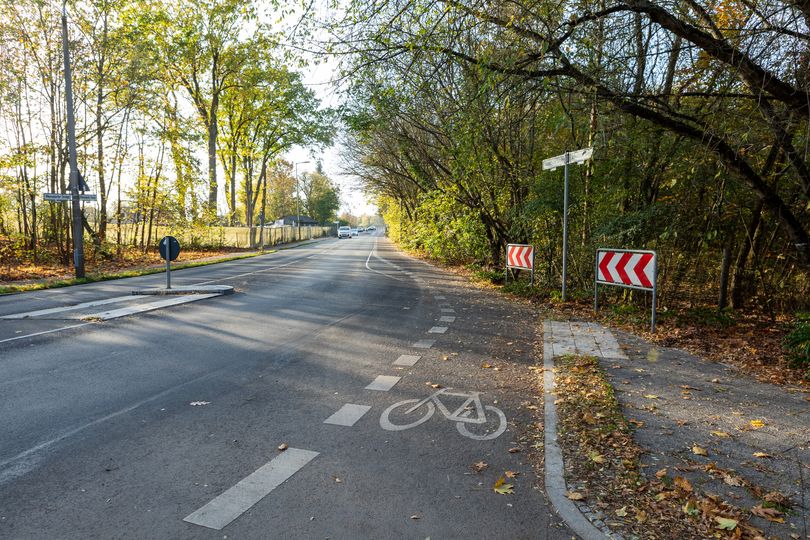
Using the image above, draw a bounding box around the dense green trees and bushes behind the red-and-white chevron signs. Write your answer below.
[312,0,810,379]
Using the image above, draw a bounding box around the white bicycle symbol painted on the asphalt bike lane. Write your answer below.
[380,388,506,441]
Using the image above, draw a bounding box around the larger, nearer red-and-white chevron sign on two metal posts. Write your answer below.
[593,248,658,332]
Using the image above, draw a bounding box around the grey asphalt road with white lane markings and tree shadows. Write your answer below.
[0,235,572,539]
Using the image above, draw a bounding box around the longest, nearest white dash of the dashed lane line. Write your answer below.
[183,448,318,530]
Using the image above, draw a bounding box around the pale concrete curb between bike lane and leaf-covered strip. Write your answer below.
[543,321,614,540]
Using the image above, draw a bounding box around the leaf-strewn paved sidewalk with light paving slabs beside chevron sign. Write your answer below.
[544,321,810,539]
